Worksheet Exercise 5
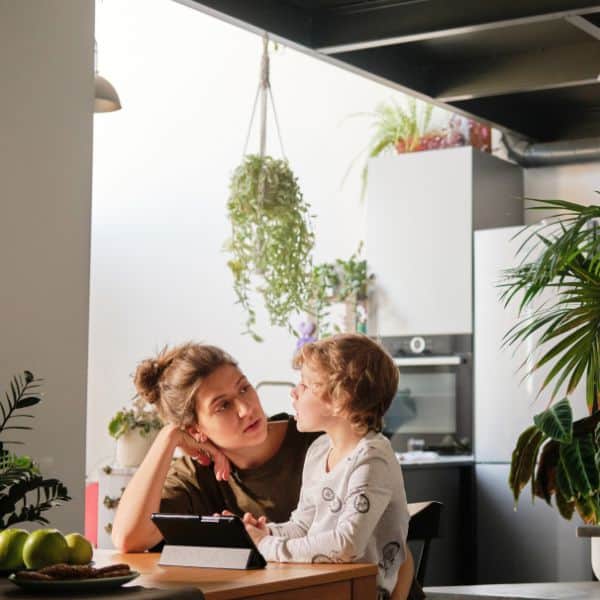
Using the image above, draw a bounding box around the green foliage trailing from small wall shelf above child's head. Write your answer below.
[311,242,373,337]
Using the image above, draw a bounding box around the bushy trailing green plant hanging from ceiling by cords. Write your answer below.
[226,154,314,341]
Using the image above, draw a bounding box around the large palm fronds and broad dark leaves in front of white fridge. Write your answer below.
[503,200,600,523]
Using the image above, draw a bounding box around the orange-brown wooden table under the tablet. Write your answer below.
[94,550,377,600]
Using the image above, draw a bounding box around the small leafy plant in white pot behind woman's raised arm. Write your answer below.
[108,396,163,467]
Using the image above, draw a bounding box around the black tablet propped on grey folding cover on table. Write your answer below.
[151,513,266,569]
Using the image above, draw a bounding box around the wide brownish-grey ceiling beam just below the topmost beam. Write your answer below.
[428,42,600,102]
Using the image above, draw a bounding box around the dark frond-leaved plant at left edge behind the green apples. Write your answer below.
[0,371,71,530]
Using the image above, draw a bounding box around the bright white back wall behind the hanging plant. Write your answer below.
[87,0,460,475]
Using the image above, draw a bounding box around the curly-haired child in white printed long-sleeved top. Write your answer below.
[244,334,409,599]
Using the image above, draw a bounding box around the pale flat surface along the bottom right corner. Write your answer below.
[425,581,600,600]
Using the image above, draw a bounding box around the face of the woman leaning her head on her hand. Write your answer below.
[196,365,267,450]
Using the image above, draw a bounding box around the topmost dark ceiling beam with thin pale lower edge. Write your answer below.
[312,0,600,54]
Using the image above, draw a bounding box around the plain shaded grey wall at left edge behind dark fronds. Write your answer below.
[0,0,94,531]
